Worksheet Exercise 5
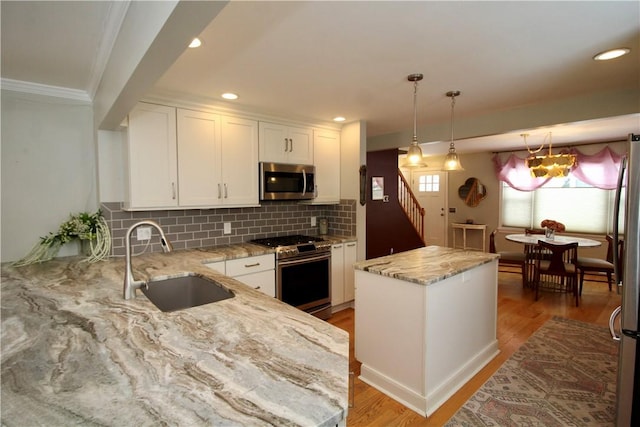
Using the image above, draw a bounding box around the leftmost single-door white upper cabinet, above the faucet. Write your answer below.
[125,103,178,209]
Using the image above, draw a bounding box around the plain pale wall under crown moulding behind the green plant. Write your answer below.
[0,90,98,262]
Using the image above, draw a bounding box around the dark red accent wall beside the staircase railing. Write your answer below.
[366,149,424,259]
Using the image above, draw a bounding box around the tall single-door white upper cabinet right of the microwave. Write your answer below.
[311,129,340,204]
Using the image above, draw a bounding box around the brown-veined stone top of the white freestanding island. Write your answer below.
[354,246,499,285]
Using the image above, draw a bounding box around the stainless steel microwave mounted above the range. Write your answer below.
[260,162,316,200]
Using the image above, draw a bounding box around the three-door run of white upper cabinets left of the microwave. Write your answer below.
[125,103,259,210]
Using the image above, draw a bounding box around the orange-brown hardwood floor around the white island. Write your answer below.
[329,272,620,427]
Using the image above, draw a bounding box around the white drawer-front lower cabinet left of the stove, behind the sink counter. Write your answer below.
[205,254,276,298]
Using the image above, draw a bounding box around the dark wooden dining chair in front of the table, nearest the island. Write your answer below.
[533,240,579,307]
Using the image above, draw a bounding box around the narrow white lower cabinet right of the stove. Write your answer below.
[331,242,358,310]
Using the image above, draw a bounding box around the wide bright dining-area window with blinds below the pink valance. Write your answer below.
[501,175,624,234]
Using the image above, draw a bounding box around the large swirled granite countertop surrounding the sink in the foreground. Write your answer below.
[1,244,349,426]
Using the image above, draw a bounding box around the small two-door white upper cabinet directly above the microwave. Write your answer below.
[260,122,313,165]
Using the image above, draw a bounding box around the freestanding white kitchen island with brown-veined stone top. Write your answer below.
[355,246,499,416]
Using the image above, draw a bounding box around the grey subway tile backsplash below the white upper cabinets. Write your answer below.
[100,200,356,256]
